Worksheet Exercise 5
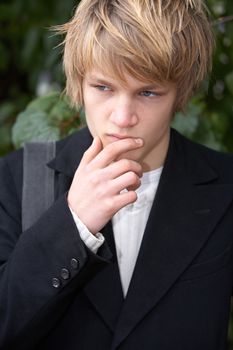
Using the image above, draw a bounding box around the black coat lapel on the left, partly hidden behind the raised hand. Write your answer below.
[49,128,124,332]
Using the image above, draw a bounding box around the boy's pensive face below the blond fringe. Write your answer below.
[83,70,177,171]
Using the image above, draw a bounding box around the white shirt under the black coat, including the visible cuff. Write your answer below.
[71,167,162,296]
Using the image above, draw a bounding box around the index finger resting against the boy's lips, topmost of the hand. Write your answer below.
[92,138,143,168]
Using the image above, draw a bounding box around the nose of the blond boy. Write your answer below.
[110,98,138,128]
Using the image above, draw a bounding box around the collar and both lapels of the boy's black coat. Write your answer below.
[47,129,233,349]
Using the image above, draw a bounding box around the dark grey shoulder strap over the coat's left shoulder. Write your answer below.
[22,141,56,231]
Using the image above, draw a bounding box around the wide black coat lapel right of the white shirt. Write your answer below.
[113,131,233,349]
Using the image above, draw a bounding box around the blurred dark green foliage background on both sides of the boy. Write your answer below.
[0,0,233,349]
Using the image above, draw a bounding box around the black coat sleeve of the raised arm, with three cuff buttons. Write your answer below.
[0,155,110,349]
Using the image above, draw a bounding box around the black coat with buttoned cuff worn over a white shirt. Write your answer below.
[0,129,233,350]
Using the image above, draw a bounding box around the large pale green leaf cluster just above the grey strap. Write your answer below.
[12,92,82,148]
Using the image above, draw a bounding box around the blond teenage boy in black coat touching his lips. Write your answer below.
[0,0,233,350]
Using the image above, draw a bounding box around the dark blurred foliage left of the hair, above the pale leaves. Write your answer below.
[0,0,77,155]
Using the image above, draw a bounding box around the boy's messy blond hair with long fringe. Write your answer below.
[59,0,214,110]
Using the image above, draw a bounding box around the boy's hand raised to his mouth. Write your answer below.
[67,137,143,234]
